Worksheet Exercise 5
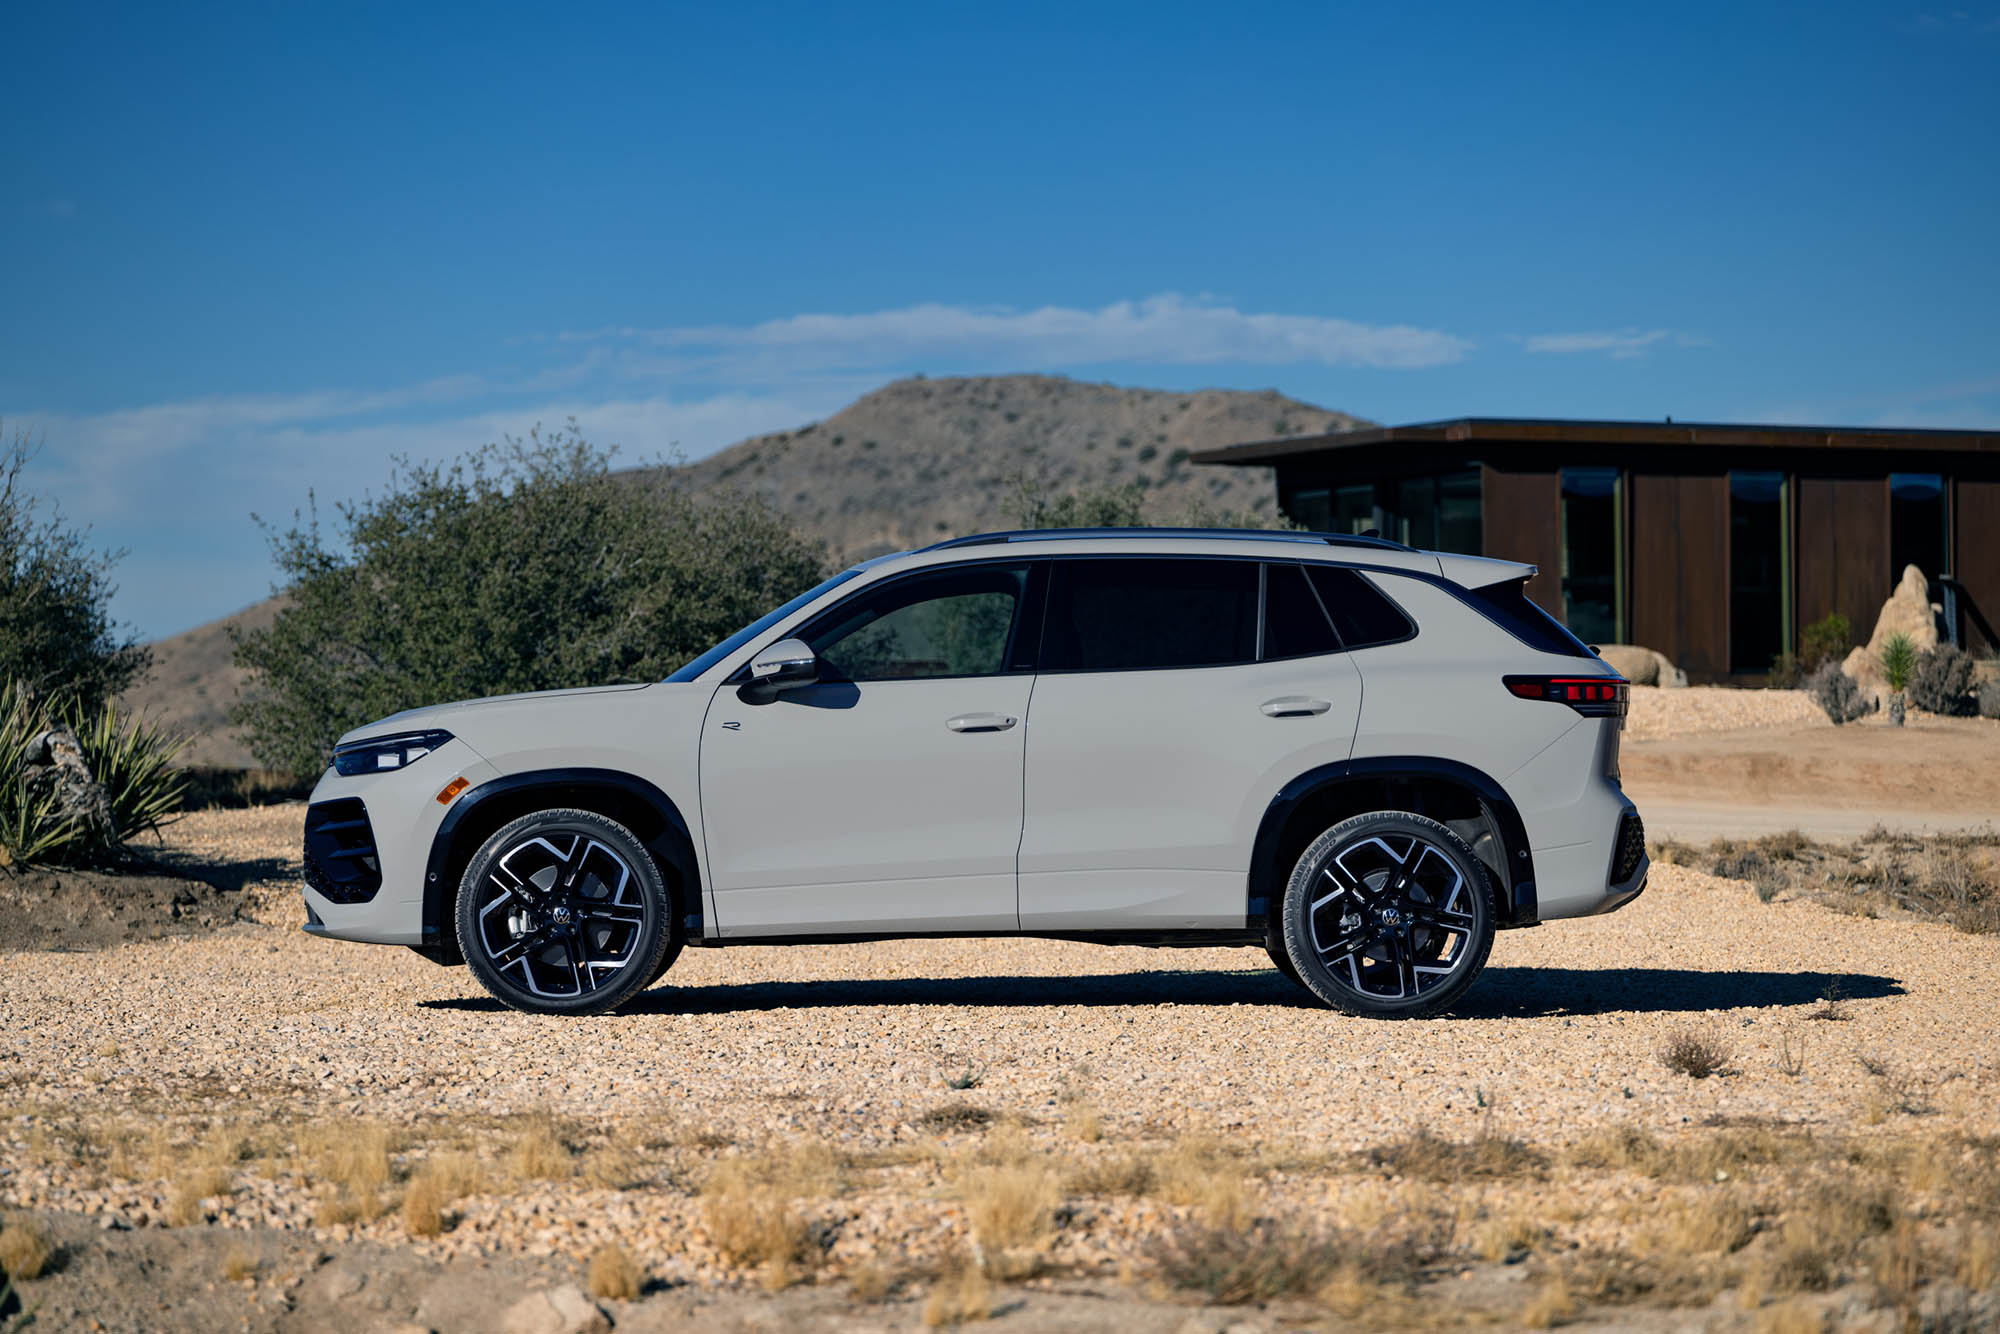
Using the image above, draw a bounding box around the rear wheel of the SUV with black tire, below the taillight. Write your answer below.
[1284,810,1494,1018]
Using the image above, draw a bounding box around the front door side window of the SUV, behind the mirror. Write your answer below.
[800,566,1028,680]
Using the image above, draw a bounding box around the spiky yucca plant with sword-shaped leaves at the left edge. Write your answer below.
[0,682,188,864]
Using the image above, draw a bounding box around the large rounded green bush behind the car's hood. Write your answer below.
[234,422,824,774]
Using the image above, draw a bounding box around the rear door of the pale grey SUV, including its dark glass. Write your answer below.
[1020,556,1360,930]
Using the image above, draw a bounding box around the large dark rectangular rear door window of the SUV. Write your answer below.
[1042,560,1258,672]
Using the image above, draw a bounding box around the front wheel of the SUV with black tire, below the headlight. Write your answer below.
[456,810,680,1014]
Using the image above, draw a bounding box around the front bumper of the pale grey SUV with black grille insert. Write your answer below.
[302,738,498,946]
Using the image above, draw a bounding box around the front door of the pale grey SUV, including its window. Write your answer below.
[702,562,1034,936]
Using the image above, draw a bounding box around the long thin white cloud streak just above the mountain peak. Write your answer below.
[556,292,1472,376]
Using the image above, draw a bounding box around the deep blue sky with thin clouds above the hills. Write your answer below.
[0,0,2000,636]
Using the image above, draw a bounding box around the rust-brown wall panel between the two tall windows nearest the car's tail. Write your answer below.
[1632,472,1730,680]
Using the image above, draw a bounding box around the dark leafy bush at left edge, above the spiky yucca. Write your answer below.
[0,432,152,708]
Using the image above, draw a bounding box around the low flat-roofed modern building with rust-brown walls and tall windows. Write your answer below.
[1194,418,2000,684]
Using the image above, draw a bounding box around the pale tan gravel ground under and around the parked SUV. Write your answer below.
[0,806,2000,1328]
